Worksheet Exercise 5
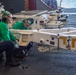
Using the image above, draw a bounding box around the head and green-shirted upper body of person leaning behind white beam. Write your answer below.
[12,18,34,30]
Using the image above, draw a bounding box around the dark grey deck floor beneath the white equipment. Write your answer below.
[0,46,76,75]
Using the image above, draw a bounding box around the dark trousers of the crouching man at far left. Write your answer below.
[0,41,14,62]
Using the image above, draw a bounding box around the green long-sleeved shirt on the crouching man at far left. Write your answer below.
[0,22,16,41]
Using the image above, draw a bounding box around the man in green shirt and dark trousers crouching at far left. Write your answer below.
[0,11,20,67]
